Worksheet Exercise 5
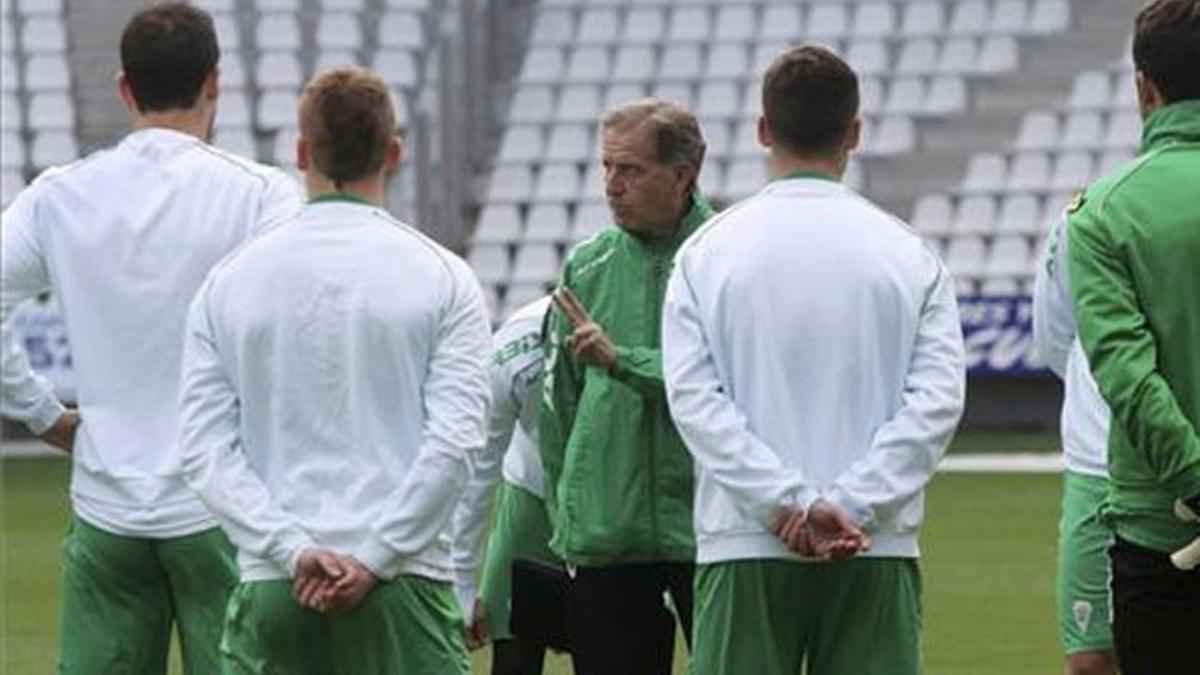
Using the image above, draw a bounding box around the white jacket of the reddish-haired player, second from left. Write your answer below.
[180,201,490,581]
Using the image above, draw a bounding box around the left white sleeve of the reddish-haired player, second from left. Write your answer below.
[180,277,313,575]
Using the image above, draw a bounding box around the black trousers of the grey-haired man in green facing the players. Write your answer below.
[568,562,696,675]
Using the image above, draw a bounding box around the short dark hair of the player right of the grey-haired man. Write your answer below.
[762,46,858,157]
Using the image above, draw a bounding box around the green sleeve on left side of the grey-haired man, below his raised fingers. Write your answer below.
[538,281,583,522]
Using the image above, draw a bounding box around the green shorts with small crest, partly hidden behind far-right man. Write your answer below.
[1055,471,1112,655]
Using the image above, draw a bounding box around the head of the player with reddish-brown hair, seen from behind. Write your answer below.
[300,66,396,184]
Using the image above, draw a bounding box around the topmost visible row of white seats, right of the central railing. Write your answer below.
[533,0,1070,46]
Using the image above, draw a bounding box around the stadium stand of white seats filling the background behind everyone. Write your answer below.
[0,0,1140,316]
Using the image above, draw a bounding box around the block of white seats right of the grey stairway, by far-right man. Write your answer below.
[912,61,1141,295]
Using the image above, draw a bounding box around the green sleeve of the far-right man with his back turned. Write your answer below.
[1068,210,1200,497]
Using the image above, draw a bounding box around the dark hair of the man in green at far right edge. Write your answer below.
[1133,0,1200,103]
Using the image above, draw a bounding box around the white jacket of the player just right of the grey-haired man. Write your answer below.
[662,177,965,563]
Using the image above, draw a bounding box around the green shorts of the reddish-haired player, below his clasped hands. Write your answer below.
[221,575,468,675]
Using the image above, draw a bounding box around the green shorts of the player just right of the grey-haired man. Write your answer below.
[691,557,922,675]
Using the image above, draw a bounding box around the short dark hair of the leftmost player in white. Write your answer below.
[121,2,221,113]
